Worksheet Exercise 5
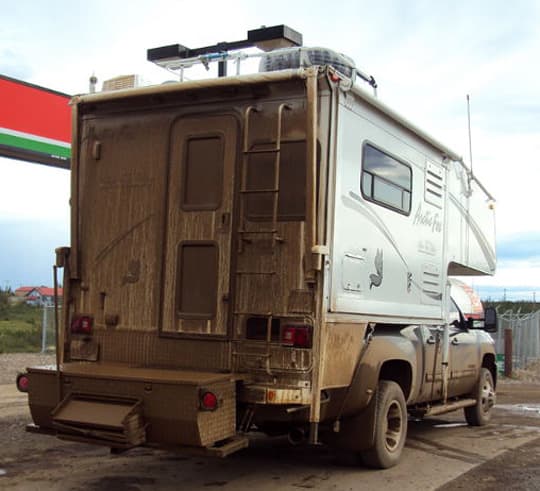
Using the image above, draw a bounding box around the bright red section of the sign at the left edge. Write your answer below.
[0,77,71,143]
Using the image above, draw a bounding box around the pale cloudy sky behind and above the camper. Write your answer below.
[0,0,540,299]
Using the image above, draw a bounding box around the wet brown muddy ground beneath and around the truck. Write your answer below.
[0,355,540,491]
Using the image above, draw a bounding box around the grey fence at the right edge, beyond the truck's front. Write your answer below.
[493,311,540,368]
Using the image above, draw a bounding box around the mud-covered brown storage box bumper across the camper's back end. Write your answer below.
[24,363,236,448]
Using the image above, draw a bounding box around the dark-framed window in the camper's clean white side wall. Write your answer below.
[361,144,412,215]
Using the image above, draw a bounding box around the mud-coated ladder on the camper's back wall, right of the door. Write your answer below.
[233,102,291,375]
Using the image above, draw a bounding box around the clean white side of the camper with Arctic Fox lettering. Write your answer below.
[325,89,495,323]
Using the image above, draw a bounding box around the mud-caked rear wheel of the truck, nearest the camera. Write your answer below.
[361,380,407,469]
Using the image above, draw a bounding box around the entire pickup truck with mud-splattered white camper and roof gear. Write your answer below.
[19,26,497,468]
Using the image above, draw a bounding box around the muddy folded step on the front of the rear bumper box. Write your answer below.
[52,394,146,448]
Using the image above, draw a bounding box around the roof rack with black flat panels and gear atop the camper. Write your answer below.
[147,25,377,95]
